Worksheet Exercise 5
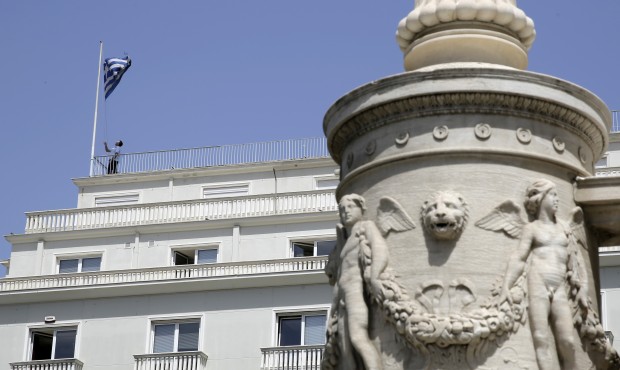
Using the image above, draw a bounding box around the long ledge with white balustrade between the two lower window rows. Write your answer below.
[0,257,327,305]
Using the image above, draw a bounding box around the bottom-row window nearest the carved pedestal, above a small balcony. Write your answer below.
[278,312,327,346]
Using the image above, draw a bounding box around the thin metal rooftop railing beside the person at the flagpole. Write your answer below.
[92,138,329,176]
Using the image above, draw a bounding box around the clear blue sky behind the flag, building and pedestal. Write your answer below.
[0,0,620,276]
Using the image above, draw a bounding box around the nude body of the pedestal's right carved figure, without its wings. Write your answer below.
[500,179,587,370]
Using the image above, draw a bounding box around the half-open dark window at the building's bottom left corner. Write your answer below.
[30,328,77,360]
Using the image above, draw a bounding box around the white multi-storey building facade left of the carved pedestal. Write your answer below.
[0,139,338,370]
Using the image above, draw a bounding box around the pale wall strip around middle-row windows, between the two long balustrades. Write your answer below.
[7,217,336,277]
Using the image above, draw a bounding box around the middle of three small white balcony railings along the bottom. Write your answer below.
[133,351,207,370]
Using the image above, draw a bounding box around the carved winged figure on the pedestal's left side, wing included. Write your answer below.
[321,194,415,370]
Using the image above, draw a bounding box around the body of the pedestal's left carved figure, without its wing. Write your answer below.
[327,194,387,370]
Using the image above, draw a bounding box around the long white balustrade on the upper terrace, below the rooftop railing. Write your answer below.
[25,191,338,234]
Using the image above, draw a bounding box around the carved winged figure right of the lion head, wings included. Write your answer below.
[476,179,617,370]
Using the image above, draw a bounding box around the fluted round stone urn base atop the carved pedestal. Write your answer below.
[396,0,536,71]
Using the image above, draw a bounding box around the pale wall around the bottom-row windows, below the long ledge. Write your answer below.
[0,285,331,370]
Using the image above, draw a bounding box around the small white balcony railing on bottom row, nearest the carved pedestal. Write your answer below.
[261,345,324,370]
